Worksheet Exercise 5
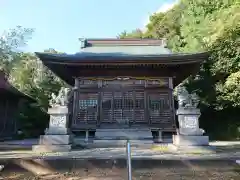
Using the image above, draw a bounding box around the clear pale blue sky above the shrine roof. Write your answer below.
[0,0,176,53]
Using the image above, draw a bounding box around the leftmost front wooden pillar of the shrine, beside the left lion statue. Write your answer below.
[72,78,80,125]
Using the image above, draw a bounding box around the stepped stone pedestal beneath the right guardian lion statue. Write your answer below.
[173,107,209,151]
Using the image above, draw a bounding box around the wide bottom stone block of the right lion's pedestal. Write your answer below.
[173,135,209,146]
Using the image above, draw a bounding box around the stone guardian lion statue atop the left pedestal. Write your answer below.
[49,87,70,107]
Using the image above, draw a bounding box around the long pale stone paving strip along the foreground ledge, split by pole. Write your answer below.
[0,148,240,160]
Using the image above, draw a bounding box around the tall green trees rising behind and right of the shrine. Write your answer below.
[121,0,240,139]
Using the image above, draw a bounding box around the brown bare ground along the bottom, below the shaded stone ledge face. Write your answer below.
[2,161,240,180]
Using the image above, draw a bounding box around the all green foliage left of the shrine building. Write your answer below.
[0,27,65,137]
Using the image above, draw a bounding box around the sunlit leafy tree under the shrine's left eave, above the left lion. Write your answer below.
[10,50,66,110]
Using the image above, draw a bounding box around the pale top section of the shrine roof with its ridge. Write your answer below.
[80,39,171,56]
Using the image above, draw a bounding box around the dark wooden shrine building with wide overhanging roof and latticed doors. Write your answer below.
[36,39,208,139]
